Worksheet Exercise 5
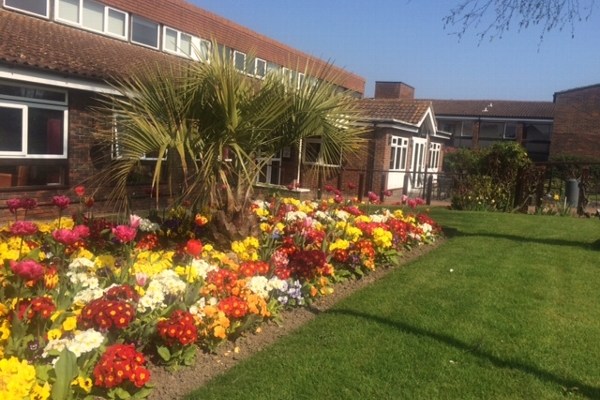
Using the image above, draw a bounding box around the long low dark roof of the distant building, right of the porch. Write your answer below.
[431,100,554,119]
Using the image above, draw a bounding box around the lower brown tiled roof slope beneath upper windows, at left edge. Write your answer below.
[0,9,181,81]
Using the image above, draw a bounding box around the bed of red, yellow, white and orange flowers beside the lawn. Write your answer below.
[0,188,440,399]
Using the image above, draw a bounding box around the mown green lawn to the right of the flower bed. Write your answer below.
[189,209,600,400]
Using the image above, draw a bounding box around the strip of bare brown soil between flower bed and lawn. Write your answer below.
[149,240,441,400]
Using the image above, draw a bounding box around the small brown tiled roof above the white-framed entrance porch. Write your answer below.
[359,99,431,125]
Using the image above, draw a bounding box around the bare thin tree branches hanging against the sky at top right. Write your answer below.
[443,0,596,42]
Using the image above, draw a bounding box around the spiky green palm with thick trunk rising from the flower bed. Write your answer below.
[93,46,362,244]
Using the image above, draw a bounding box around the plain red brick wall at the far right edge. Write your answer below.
[550,85,600,160]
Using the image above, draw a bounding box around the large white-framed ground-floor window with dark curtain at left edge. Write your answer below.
[0,82,68,188]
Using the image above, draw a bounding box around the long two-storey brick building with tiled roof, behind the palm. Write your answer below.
[0,0,365,219]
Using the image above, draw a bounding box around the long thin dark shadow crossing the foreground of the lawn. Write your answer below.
[325,309,600,399]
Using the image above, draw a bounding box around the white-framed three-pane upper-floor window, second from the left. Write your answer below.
[56,0,127,39]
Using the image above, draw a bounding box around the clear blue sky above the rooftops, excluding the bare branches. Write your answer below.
[189,0,600,101]
